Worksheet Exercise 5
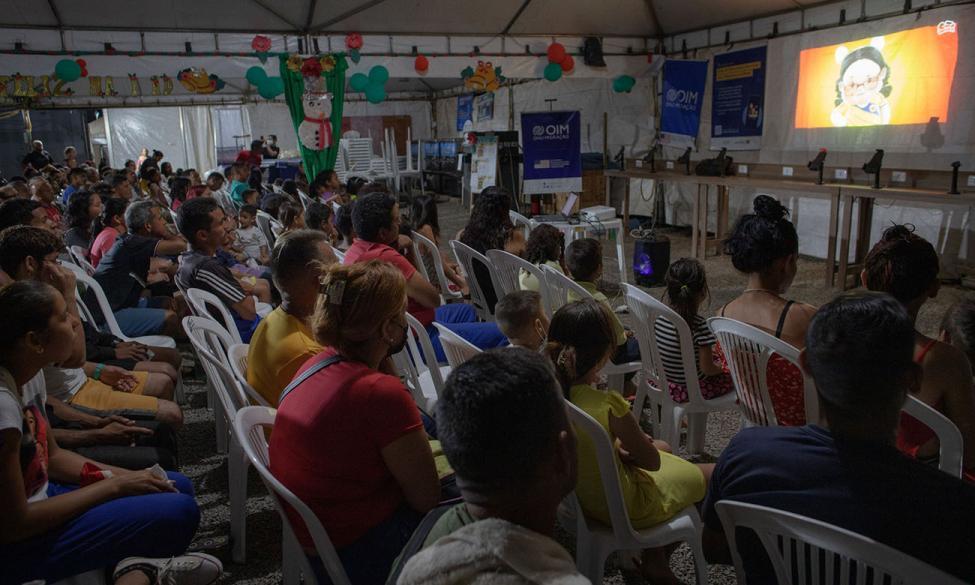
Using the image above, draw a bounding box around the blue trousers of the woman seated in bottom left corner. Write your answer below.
[0,473,200,585]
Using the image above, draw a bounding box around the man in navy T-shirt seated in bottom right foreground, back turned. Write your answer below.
[700,292,975,584]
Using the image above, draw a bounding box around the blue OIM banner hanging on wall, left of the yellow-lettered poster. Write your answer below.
[660,59,708,148]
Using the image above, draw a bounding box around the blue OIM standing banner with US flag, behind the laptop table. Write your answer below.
[521,112,582,194]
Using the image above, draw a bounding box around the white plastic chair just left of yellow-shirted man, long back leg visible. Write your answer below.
[183,317,250,563]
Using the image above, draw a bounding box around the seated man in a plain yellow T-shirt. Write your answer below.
[247,230,335,406]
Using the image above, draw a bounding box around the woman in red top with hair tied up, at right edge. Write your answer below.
[860,225,975,481]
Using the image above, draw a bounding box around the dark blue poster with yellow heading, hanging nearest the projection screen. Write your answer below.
[711,47,767,150]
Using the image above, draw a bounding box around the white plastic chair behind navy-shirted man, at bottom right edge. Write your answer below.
[715,500,964,585]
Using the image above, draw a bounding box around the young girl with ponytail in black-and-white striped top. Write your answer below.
[653,258,734,402]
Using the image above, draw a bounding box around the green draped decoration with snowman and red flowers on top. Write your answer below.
[276,53,348,178]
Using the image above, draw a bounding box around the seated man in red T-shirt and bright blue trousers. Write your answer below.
[345,193,507,362]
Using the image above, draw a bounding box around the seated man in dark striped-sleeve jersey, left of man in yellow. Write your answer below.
[176,197,260,343]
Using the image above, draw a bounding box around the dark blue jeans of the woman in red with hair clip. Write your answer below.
[308,503,423,585]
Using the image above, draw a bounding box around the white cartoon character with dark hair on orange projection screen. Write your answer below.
[830,37,891,126]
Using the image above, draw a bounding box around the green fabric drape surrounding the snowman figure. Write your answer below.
[278,53,349,182]
